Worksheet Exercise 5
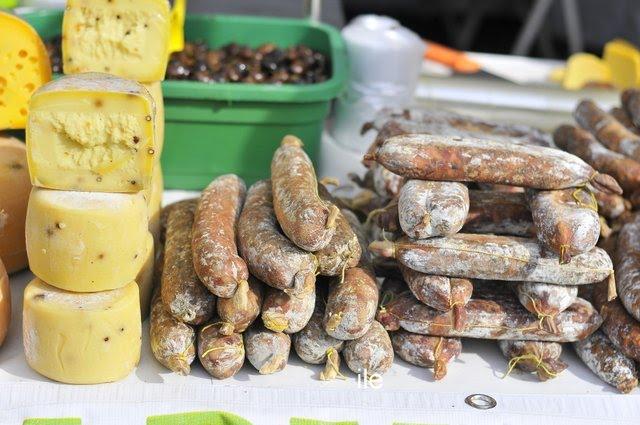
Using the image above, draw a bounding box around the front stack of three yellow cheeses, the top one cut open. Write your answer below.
[23,73,159,384]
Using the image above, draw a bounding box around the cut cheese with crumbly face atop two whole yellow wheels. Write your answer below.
[27,73,159,192]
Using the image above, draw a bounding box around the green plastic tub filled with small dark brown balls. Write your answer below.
[23,11,347,189]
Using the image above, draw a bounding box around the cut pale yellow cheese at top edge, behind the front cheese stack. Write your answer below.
[62,0,170,82]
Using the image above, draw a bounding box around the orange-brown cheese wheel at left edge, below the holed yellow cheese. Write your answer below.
[0,137,31,273]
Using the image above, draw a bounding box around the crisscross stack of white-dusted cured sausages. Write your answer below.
[342,109,628,380]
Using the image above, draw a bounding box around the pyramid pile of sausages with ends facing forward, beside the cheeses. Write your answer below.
[150,136,393,380]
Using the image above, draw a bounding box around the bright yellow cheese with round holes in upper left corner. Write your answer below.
[0,12,51,130]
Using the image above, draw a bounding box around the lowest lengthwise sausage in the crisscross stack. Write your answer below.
[393,293,602,342]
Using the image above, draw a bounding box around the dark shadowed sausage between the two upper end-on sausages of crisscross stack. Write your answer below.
[461,190,535,237]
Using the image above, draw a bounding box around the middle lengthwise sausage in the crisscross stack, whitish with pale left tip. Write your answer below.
[369,233,613,285]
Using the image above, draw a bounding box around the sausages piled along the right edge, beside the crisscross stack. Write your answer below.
[553,93,640,392]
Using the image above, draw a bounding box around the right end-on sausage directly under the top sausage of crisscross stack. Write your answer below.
[527,189,600,264]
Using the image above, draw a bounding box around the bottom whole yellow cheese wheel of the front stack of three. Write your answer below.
[22,278,142,384]
